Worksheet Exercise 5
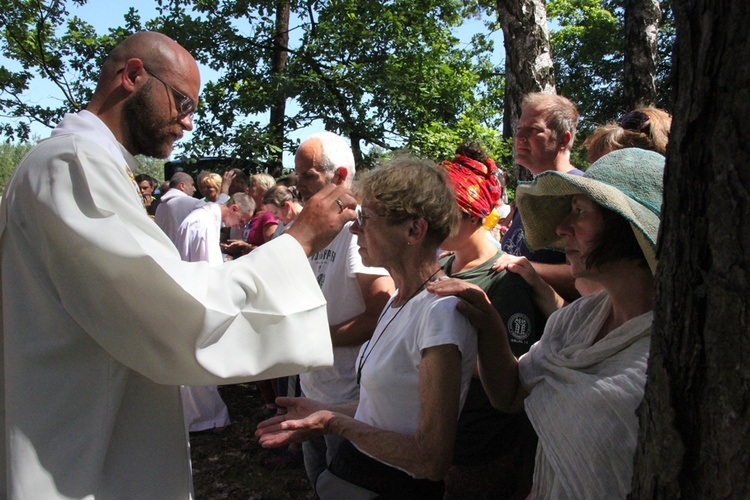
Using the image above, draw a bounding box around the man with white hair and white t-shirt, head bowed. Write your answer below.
[294,132,394,487]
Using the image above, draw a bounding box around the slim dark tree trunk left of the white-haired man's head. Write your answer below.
[268,0,289,177]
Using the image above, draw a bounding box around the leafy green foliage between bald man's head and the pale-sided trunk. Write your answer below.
[148,0,502,168]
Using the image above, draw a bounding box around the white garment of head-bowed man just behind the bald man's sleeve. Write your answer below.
[175,203,224,266]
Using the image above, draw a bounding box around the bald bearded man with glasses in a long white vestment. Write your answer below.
[0,32,356,499]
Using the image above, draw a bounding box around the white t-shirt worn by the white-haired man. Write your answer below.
[300,222,388,404]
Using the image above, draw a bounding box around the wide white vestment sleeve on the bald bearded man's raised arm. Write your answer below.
[0,136,332,385]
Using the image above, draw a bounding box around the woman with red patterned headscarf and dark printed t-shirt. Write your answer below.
[440,143,544,499]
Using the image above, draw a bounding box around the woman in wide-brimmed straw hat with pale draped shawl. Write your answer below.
[429,148,664,498]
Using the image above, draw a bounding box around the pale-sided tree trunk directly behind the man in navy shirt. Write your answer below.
[497,0,555,180]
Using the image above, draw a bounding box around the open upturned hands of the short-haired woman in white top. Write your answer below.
[255,398,332,448]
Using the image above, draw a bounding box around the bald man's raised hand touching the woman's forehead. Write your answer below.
[287,184,357,255]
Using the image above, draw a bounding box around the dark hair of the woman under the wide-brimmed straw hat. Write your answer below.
[585,205,648,269]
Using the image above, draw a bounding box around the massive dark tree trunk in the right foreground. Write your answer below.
[631,0,750,499]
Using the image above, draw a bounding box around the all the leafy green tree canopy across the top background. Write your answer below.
[0,0,674,178]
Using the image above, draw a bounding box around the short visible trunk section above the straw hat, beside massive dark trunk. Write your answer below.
[623,0,661,112]
